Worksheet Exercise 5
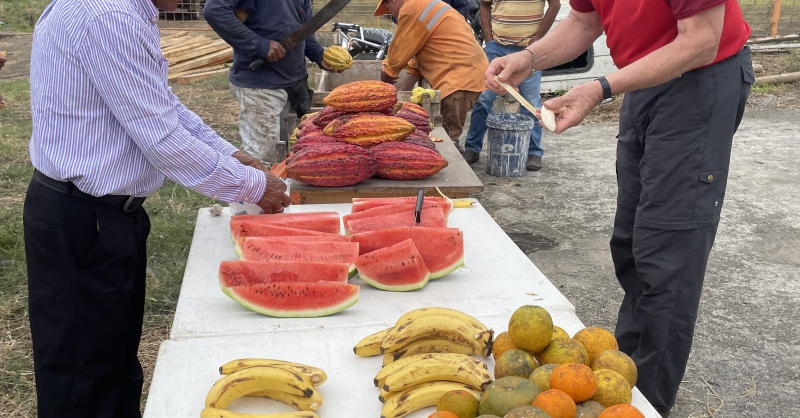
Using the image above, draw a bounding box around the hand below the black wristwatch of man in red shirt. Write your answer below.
[536,81,603,134]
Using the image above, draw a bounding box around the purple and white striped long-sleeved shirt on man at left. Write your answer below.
[30,0,266,202]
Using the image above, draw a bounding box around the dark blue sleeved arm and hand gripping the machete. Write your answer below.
[203,0,286,62]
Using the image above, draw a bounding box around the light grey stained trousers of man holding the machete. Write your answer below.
[230,84,290,168]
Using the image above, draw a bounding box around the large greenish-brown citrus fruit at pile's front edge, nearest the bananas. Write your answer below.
[479,376,539,417]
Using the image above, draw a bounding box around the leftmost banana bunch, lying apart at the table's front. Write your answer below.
[205,358,328,418]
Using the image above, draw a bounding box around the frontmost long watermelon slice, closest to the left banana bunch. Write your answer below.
[227,281,360,318]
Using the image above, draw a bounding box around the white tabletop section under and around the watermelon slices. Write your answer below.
[170,201,575,338]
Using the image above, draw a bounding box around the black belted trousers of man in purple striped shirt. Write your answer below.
[23,179,150,418]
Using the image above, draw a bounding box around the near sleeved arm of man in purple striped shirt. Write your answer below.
[77,12,268,204]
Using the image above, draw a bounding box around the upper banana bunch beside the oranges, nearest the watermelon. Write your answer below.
[353,308,494,365]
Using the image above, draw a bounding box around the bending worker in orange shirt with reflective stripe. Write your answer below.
[375,0,489,146]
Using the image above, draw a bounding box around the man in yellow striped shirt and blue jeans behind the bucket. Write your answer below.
[462,0,561,171]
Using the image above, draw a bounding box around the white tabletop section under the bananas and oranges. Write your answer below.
[144,310,660,418]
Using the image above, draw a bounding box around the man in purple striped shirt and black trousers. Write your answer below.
[23,0,290,418]
